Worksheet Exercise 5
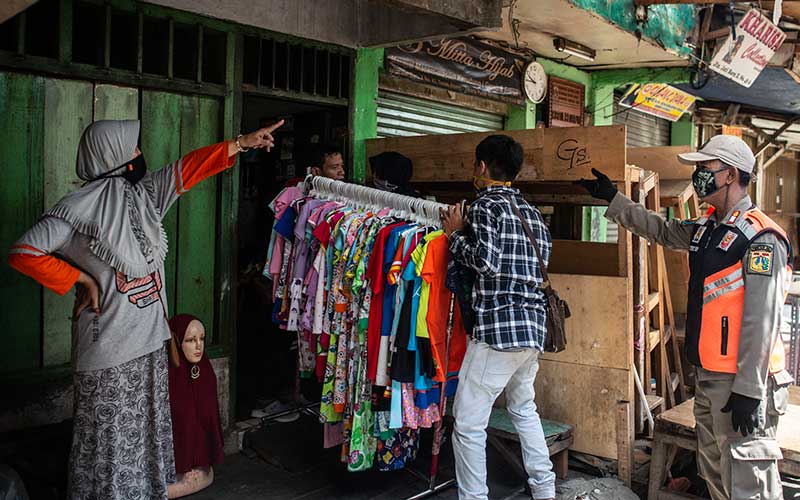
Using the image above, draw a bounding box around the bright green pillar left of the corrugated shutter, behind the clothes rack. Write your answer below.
[350,49,383,182]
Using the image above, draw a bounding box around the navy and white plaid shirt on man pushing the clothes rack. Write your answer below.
[450,186,552,351]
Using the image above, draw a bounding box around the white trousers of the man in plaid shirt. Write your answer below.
[453,342,556,500]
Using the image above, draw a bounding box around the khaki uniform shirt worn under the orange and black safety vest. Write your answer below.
[606,193,791,399]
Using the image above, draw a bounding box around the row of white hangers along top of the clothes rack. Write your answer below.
[305,175,449,228]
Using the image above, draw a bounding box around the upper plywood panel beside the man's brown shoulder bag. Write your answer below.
[542,274,633,370]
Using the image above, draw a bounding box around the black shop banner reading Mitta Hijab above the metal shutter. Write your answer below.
[384,38,526,105]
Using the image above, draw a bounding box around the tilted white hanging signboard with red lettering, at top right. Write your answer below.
[711,9,786,88]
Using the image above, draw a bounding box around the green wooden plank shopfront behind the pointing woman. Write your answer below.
[0,72,221,373]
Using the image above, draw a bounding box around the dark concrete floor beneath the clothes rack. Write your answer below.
[186,416,528,500]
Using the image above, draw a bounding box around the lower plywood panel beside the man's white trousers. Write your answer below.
[535,360,633,459]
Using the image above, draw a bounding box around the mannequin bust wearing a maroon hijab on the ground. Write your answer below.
[167,314,223,498]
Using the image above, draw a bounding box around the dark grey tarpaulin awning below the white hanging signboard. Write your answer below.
[675,67,800,117]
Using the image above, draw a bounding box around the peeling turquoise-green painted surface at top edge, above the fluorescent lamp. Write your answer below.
[570,0,697,55]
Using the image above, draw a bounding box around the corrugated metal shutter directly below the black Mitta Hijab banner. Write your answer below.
[378,91,505,137]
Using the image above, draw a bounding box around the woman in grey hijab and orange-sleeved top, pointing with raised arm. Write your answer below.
[9,120,282,500]
